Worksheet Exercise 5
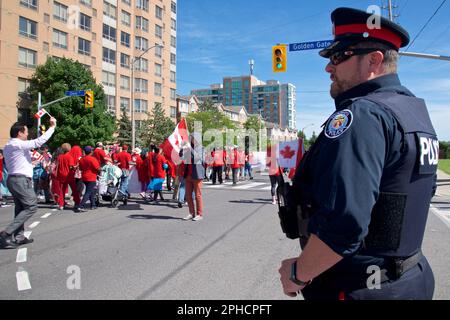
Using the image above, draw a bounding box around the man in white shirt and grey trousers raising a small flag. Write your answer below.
[0,117,56,249]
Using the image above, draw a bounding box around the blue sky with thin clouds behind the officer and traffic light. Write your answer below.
[177,0,450,141]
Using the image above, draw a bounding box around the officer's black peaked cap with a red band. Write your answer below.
[319,8,409,58]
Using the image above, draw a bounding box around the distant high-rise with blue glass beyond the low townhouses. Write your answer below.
[191,75,296,129]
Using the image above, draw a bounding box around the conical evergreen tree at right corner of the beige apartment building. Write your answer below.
[139,103,175,146]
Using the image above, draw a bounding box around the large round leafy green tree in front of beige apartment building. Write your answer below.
[28,58,116,149]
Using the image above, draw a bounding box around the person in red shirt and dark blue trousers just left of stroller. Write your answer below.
[75,146,100,212]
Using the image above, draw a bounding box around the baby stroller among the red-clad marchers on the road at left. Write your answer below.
[96,164,128,208]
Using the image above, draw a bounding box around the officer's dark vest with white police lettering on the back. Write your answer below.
[360,92,439,257]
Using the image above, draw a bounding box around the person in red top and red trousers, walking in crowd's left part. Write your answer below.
[57,143,80,210]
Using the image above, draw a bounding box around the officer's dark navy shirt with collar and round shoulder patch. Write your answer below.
[308,74,413,257]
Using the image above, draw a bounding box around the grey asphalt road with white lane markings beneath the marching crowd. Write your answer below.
[0,177,450,300]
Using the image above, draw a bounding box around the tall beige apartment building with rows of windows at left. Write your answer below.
[0,0,177,145]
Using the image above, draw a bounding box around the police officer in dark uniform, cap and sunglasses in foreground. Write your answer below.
[279,8,438,300]
